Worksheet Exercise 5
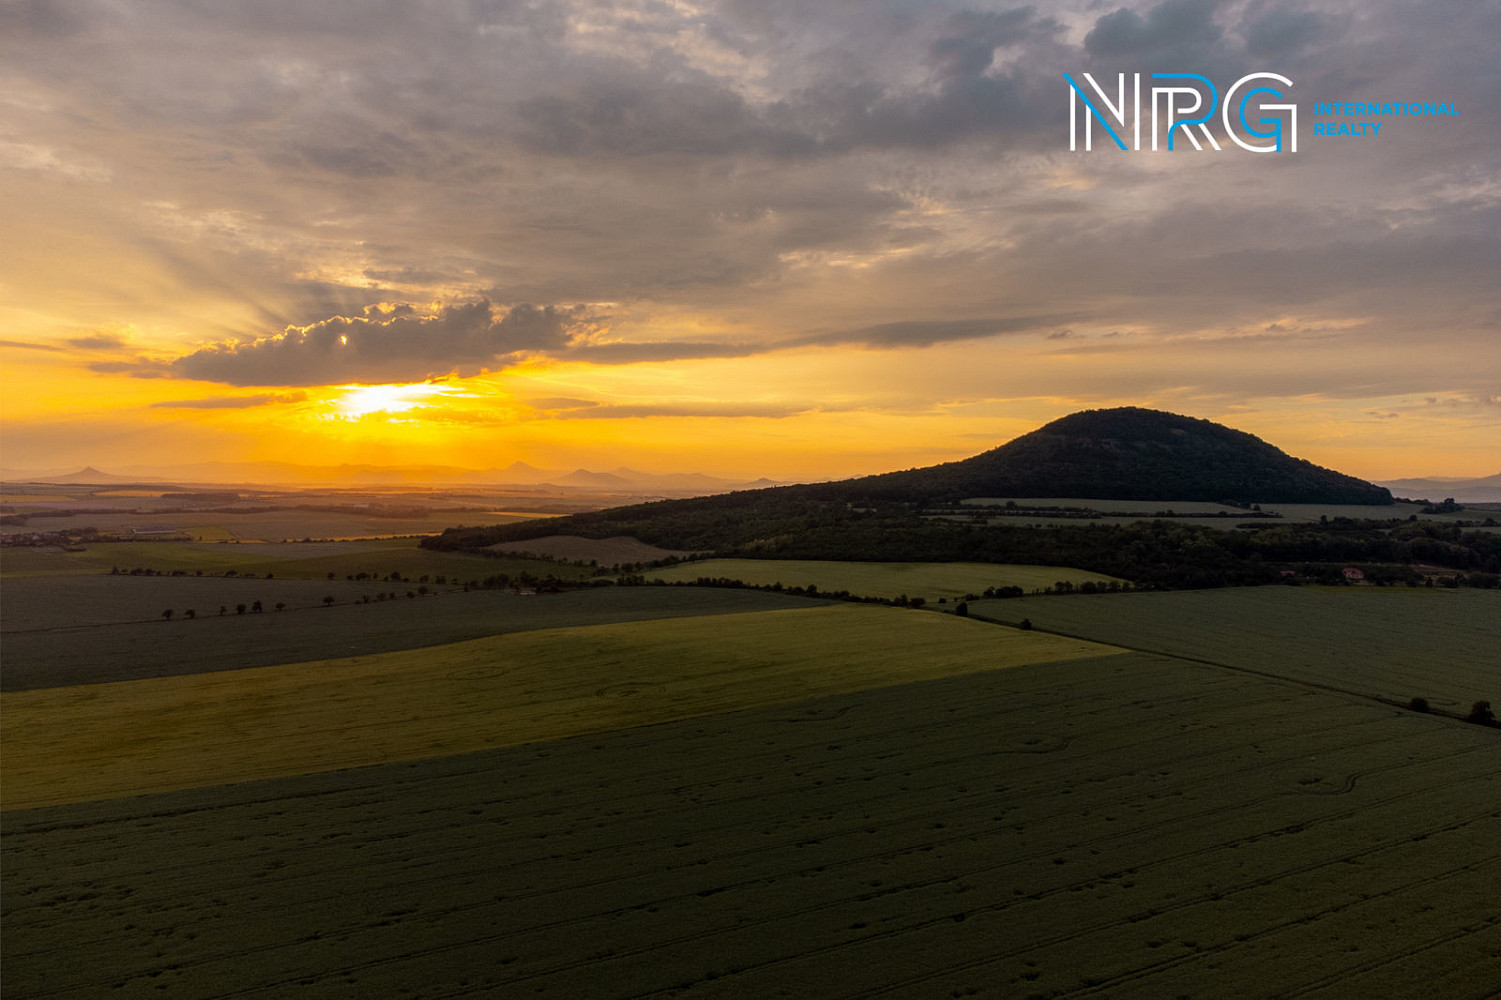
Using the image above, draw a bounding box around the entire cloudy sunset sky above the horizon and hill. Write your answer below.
[0,0,1501,479]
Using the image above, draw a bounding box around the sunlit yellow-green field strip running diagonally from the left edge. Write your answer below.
[0,605,1118,809]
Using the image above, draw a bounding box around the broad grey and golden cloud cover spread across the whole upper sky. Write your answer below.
[0,0,1501,447]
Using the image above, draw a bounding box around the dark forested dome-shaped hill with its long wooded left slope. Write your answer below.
[423,408,1391,559]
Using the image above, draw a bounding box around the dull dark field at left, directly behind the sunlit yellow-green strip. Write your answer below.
[0,577,826,691]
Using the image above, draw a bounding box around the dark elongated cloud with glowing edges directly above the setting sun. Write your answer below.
[171,300,582,386]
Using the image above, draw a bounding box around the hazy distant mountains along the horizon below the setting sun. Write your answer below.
[0,462,776,494]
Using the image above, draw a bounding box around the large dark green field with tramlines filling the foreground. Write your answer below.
[3,655,1501,1000]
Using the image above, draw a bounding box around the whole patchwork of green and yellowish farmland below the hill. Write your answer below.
[0,492,1501,1000]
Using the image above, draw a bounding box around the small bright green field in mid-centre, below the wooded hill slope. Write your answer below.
[648,559,1111,601]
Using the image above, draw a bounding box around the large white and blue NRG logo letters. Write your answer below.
[1063,74,1298,153]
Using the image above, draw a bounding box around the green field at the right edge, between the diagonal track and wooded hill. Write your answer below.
[970,587,1501,710]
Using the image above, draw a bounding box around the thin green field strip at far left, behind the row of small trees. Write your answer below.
[0,538,593,580]
